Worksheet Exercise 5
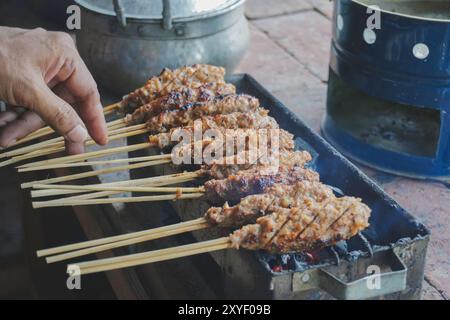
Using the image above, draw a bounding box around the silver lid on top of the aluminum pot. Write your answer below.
[75,0,244,20]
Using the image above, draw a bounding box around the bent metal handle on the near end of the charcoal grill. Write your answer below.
[292,249,408,300]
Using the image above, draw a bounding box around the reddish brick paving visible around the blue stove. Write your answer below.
[237,0,450,299]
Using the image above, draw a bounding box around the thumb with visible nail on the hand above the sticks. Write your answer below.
[32,85,88,154]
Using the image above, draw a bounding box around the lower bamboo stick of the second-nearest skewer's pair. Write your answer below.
[45,218,209,263]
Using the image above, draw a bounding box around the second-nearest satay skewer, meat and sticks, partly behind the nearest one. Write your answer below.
[39,178,338,257]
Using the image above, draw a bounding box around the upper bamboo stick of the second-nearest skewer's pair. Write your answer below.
[37,218,207,258]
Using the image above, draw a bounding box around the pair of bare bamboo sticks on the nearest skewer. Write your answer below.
[72,237,231,275]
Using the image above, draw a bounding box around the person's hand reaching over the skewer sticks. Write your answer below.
[0,27,108,154]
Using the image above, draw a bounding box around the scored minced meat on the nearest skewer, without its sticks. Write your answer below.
[230,197,370,253]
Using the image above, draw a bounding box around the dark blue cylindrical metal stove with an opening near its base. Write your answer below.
[322,0,450,182]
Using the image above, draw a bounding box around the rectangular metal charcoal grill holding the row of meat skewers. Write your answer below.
[125,75,429,299]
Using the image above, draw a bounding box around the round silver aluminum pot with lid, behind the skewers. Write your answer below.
[75,0,249,94]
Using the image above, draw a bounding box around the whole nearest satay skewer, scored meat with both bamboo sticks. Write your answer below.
[69,198,370,275]
